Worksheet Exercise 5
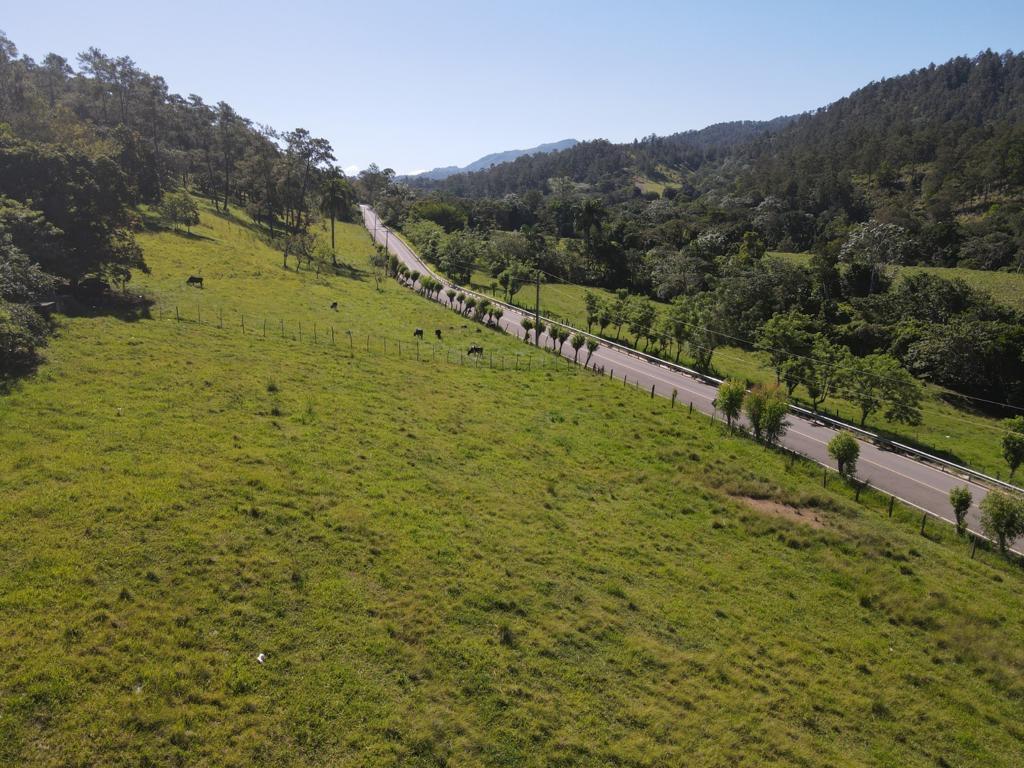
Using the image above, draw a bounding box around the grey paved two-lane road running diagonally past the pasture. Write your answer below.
[361,206,1019,549]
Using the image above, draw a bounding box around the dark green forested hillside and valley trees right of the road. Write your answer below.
[372,51,1024,425]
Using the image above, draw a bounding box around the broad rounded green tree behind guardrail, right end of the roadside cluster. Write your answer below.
[842,354,922,426]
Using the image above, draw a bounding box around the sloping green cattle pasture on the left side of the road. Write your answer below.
[0,201,1024,766]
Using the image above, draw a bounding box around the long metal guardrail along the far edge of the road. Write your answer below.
[367,206,1024,494]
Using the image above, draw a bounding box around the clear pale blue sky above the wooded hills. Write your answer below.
[0,0,1024,173]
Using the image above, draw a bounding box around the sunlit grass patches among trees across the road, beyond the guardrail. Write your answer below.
[458,259,1024,479]
